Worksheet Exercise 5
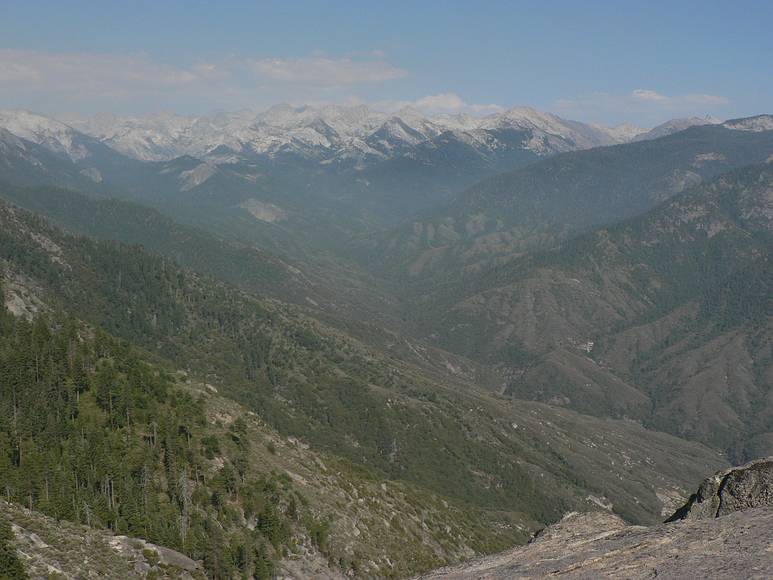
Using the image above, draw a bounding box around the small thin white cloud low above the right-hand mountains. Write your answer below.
[552,89,730,123]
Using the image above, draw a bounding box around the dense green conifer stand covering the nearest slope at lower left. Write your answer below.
[0,312,314,578]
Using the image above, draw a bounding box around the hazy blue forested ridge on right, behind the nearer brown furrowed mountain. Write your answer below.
[351,116,773,291]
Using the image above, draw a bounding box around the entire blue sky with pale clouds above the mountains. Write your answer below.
[0,0,773,125]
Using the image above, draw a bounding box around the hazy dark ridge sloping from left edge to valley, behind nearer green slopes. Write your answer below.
[0,183,410,336]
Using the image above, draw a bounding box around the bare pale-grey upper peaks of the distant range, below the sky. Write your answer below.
[55,105,643,165]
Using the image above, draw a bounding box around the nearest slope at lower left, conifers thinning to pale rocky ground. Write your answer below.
[0,304,532,578]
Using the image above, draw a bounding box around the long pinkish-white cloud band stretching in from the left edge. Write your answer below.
[0,49,409,109]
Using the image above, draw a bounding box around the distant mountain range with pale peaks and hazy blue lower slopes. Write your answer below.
[0,105,736,232]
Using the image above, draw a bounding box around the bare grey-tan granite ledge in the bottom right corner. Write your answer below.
[421,458,773,580]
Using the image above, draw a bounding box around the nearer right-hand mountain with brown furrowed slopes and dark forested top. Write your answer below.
[414,163,773,458]
